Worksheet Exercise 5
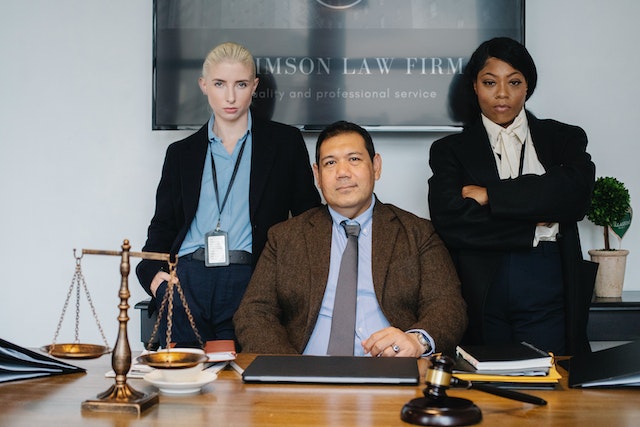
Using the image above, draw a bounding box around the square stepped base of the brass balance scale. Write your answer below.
[82,384,159,415]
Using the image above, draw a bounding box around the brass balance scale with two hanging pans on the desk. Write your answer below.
[42,239,207,415]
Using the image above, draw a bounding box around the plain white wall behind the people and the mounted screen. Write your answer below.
[0,0,640,349]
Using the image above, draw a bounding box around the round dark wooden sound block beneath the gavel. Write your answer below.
[400,396,482,426]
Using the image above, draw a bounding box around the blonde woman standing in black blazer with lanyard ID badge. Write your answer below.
[136,42,320,346]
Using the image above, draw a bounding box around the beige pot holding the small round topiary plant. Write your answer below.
[589,249,629,298]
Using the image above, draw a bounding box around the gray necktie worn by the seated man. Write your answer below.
[327,221,360,356]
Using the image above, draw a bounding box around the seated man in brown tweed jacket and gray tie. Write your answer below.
[234,122,467,357]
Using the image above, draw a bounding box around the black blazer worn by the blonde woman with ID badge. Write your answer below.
[136,117,320,295]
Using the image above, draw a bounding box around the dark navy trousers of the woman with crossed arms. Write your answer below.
[483,242,565,355]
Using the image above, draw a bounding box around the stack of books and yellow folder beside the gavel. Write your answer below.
[453,342,560,389]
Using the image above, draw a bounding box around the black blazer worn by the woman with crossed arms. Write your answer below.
[429,113,596,354]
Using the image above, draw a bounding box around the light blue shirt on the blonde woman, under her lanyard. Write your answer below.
[178,114,253,257]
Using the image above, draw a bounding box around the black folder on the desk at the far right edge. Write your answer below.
[569,341,640,387]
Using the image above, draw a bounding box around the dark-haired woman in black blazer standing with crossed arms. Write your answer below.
[429,37,596,354]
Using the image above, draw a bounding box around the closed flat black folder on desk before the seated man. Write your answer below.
[242,355,419,385]
